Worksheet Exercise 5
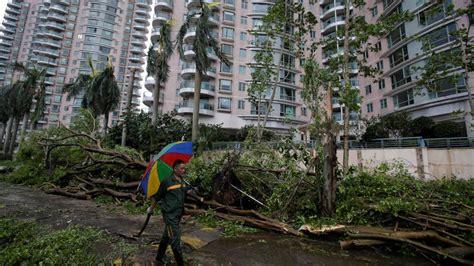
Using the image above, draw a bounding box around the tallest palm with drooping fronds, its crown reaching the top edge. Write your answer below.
[176,0,230,142]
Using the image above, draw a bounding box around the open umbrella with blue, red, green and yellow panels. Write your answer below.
[139,141,193,198]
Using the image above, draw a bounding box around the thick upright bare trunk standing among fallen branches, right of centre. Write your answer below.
[320,83,337,216]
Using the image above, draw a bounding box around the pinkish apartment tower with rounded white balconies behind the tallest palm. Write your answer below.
[145,0,310,133]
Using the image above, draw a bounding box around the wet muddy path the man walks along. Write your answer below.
[0,183,429,265]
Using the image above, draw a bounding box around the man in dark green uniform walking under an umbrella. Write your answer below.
[147,160,202,265]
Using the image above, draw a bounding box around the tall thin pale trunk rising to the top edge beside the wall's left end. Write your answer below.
[342,1,351,173]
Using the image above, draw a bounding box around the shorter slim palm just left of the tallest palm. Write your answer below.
[146,20,173,125]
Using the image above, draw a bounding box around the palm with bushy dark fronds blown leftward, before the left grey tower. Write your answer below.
[63,57,120,132]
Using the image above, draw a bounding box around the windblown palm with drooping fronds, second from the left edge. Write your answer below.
[12,62,46,133]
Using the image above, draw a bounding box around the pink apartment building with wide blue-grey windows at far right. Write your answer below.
[361,0,474,137]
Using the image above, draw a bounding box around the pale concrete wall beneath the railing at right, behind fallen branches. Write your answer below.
[337,148,474,179]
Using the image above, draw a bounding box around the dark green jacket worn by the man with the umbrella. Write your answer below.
[153,176,189,217]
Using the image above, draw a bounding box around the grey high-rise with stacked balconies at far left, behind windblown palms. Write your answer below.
[0,0,151,127]
